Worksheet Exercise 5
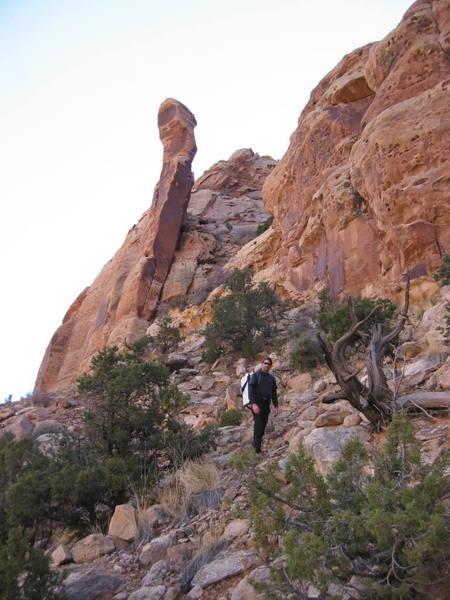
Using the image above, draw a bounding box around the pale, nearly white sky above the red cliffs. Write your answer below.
[0,0,411,402]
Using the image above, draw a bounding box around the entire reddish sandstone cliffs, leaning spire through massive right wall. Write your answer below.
[36,0,450,392]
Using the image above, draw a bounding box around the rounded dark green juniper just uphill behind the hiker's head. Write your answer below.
[203,269,280,362]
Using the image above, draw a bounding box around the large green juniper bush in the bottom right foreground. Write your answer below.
[239,415,450,600]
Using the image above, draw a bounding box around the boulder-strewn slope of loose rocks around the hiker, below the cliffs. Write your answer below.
[0,286,450,600]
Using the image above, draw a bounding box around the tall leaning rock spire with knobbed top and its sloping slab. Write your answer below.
[35,99,196,392]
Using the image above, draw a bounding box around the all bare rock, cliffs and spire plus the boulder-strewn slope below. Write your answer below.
[0,0,450,600]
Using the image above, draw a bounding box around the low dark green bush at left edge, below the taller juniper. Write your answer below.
[0,436,130,544]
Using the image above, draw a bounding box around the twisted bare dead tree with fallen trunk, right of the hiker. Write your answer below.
[318,279,450,429]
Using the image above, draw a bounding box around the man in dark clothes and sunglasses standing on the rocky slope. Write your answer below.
[248,356,278,454]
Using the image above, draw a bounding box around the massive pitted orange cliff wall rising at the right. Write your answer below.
[264,0,450,301]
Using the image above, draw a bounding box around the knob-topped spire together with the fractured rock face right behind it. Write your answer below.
[35,131,276,392]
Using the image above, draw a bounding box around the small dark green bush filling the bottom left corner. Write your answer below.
[0,527,65,600]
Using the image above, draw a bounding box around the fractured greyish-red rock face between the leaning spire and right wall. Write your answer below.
[161,148,276,307]
